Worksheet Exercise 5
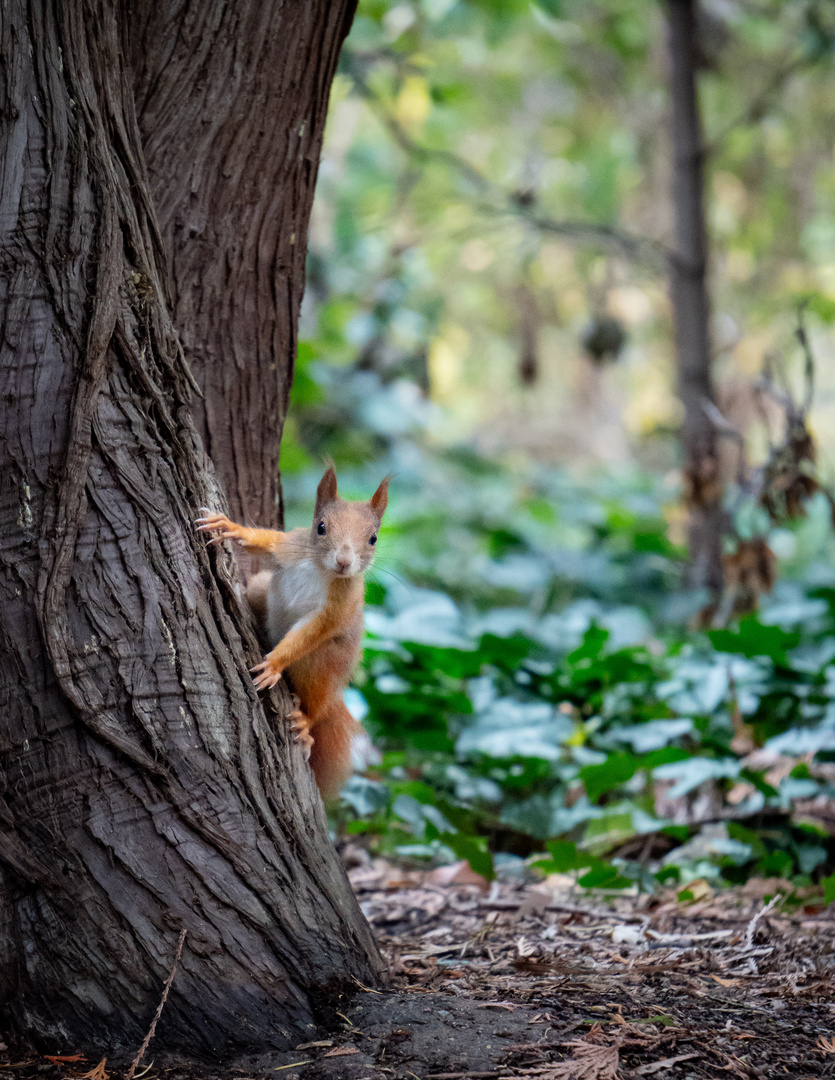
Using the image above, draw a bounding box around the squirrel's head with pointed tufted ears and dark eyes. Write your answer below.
[312,465,390,578]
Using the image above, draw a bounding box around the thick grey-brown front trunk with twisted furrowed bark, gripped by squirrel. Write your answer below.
[0,0,380,1055]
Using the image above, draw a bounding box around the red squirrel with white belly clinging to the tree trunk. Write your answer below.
[196,467,390,798]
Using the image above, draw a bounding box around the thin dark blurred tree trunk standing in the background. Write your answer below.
[666,0,725,603]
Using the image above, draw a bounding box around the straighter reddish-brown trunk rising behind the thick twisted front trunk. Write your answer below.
[132,0,356,527]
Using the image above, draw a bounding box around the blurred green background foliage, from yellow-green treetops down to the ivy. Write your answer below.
[282,0,835,902]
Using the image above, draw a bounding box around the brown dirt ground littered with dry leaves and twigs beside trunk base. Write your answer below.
[0,850,835,1080]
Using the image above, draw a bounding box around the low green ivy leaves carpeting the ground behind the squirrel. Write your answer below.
[288,446,835,892]
